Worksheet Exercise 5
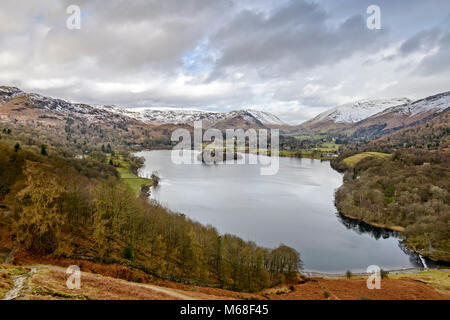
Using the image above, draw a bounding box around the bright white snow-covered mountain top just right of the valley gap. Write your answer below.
[309,98,411,123]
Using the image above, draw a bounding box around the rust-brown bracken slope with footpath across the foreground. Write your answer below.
[0,261,450,300]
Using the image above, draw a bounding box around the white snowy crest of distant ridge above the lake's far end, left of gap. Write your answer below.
[99,106,285,125]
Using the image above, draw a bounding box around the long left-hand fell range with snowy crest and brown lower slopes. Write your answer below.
[0,86,285,152]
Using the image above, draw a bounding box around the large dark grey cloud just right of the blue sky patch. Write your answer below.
[208,1,385,79]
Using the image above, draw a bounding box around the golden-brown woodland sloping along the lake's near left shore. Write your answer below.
[0,142,302,291]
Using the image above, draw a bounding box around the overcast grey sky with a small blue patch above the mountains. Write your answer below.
[0,0,450,123]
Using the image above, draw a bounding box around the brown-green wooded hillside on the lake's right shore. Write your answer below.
[333,148,450,262]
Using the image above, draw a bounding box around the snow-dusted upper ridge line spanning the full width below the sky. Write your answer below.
[0,86,450,142]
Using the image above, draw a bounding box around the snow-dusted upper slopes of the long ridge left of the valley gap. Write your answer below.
[0,86,284,129]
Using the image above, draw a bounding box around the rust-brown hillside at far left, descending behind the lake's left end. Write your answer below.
[0,87,186,154]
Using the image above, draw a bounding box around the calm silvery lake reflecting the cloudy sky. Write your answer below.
[136,150,422,272]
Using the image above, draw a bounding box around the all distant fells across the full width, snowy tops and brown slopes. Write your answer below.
[0,86,450,150]
